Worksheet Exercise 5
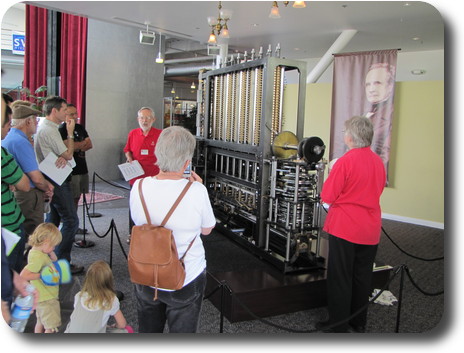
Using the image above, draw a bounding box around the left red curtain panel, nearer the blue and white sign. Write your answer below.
[23,5,47,93]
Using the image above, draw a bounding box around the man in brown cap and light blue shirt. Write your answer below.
[3,105,54,236]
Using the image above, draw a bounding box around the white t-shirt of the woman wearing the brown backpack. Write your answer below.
[130,177,216,286]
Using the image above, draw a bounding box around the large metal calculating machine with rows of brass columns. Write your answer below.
[193,56,325,273]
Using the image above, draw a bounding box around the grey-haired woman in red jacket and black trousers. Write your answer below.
[318,116,386,332]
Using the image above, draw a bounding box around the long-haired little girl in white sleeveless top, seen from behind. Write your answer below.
[65,261,133,333]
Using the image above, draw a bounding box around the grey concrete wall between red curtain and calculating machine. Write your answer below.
[85,19,164,180]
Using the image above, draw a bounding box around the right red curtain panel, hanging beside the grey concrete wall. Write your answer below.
[60,13,87,125]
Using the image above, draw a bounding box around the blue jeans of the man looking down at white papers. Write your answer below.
[46,181,79,262]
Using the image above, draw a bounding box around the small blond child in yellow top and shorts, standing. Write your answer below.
[20,223,62,333]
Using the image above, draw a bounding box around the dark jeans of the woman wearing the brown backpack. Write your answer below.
[135,270,206,333]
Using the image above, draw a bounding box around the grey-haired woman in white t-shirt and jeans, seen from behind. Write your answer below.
[130,126,216,333]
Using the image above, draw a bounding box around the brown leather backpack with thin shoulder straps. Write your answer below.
[128,179,196,300]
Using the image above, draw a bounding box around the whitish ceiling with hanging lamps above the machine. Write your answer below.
[31,1,445,59]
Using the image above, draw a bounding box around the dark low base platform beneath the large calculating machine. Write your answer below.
[205,266,391,323]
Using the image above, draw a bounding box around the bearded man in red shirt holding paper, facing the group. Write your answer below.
[124,107,162,242]
